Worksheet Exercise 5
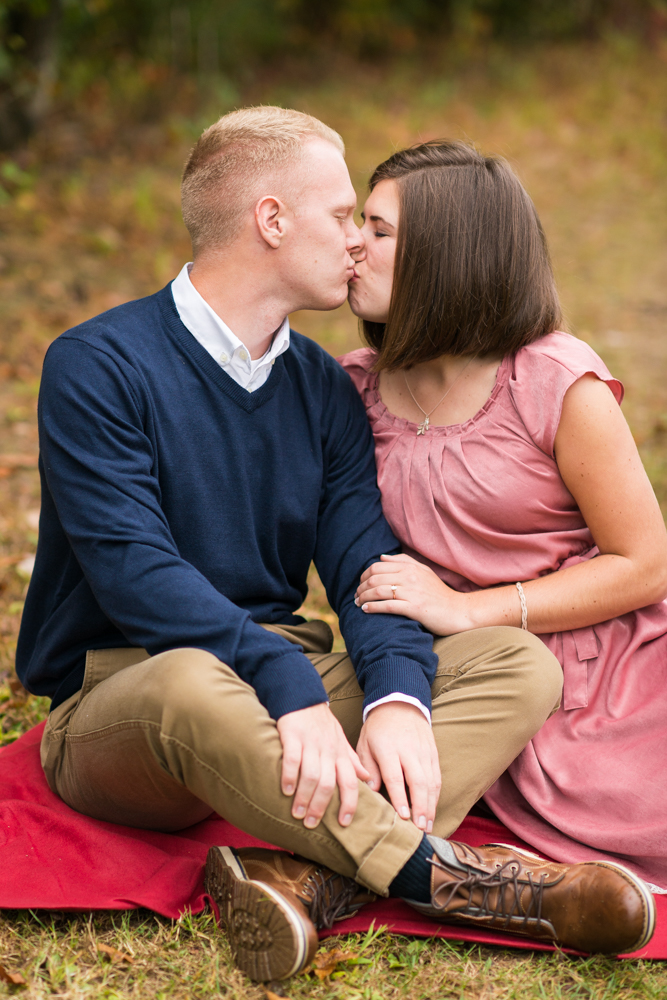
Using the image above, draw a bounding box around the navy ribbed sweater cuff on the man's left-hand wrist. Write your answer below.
[251,651,329,722]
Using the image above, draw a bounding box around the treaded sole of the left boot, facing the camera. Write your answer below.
[204,847,309,982]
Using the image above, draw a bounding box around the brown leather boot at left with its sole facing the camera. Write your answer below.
[204,847,376,982]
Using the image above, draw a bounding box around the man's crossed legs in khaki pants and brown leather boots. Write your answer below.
[37,623,653,978]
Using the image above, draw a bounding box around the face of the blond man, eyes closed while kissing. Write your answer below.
[280,139,364,309]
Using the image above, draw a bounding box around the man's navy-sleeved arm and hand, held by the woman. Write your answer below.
[315,369,440,830]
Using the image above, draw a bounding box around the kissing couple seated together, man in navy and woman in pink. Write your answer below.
[17,107,667,980]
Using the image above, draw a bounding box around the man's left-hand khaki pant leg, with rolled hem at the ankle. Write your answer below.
[42,629,421,894]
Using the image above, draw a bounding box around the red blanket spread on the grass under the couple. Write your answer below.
[0,726,667,958]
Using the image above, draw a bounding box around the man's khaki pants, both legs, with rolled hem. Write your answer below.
[42,622,562,895]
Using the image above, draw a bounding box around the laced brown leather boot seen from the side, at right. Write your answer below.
[406,837,655,955]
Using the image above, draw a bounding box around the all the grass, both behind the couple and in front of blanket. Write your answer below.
[0,39,667,1000]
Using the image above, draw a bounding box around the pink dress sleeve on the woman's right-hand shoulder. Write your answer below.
[509,332,623,457]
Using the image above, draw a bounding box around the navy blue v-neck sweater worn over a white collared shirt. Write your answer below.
[17,287,437,719]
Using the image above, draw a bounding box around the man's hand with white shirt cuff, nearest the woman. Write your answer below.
[357,701,442,833]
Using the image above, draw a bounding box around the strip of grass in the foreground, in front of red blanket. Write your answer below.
[0,911,667,1000]
